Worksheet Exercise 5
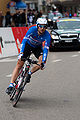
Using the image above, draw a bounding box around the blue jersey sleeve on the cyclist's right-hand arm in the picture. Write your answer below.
[42,34,51,63]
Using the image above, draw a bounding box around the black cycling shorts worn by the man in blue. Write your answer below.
[18,42,43,60]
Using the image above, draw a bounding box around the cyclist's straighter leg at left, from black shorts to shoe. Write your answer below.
[6,42,31,93]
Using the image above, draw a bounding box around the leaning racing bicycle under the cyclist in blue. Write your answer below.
[10,58,40,107]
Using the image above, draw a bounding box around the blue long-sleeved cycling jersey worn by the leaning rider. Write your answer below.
[20,26,51,62]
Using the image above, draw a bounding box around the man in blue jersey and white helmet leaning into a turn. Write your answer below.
[6,18,51,94]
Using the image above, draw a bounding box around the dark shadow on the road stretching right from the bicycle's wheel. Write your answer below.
[16,98,72,109]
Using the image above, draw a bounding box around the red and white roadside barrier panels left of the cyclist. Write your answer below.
[0,27,29,58]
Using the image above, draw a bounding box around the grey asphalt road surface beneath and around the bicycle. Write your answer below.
[0,51,80,120]
